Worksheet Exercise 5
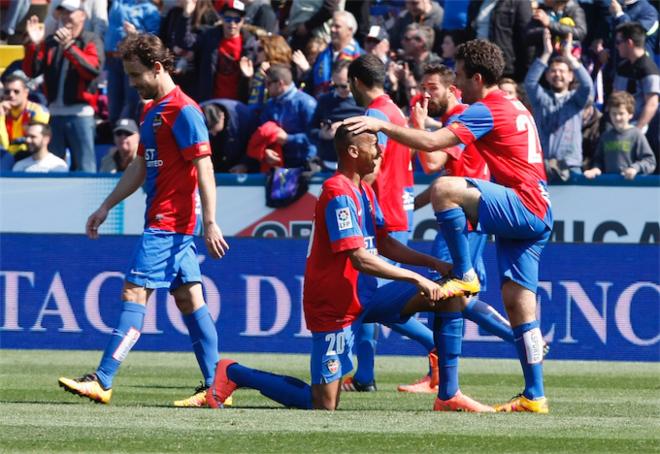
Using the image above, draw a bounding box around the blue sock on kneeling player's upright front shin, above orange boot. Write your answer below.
[434,312,463,400]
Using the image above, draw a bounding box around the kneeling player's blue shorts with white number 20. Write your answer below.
[310,281,418,385]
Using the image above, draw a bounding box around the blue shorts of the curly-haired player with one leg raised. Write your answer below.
[467,178,552,293]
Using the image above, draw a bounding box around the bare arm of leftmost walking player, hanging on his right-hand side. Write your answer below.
[193,156,229,259]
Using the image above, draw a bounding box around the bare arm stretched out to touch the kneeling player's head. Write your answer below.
[344,116,460,151]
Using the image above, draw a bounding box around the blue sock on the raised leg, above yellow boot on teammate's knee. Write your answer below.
[435,208,472,278]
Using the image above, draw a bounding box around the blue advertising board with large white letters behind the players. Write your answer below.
[0,233,660,361]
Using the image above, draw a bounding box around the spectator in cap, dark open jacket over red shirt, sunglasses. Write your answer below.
[190,0,257,102]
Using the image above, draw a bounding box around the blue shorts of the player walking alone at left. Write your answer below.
[126,229,202,291]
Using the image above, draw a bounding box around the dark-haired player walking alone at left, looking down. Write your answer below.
[59,34,228,407]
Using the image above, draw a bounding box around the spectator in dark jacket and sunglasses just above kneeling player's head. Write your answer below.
[310,61,364,172]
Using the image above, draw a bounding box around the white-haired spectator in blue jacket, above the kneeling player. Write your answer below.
[312,11,362,98]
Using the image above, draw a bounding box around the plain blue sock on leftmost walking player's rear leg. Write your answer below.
[183,304,220,386]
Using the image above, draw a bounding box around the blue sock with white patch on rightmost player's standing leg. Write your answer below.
[513,320,545,399]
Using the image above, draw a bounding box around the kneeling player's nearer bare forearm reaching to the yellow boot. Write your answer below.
[348,248,443,301]
